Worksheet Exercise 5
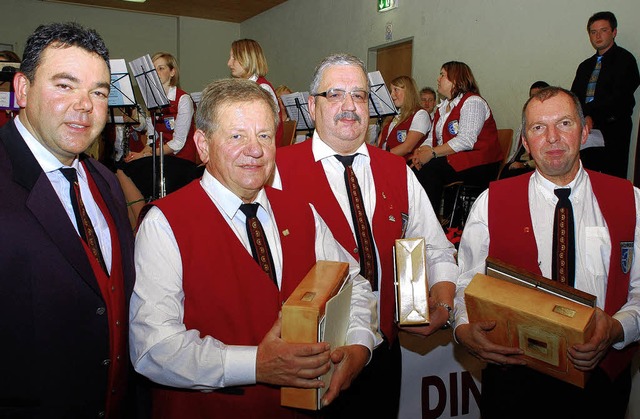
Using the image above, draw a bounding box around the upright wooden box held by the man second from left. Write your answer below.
[280,261,350,410]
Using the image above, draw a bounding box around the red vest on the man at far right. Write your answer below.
[488,170,637,378]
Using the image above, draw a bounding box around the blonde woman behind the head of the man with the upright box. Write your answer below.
[227,39,285,146]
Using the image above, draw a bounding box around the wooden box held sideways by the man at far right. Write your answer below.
[465,265,595,388]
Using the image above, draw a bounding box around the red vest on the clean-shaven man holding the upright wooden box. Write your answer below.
[148,180,315,419]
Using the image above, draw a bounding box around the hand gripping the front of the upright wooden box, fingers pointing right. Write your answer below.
[256,319,331,388]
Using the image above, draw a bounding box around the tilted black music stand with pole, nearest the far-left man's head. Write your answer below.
[129,54,170,199]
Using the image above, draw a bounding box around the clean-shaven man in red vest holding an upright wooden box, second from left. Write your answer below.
[130,79,381,419]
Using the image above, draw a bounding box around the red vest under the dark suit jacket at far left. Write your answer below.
[84,168,129,418]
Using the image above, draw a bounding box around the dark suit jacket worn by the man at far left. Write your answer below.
[0,122,134,418]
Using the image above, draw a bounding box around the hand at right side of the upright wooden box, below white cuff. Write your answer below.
[322,345,369,406]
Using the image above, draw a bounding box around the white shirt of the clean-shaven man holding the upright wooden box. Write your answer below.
[130,171,382,390]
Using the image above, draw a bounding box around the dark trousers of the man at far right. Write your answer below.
[480,364,631,419]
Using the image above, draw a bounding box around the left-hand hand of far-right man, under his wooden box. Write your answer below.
[455,321,527,365]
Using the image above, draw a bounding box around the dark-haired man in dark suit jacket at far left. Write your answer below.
[0,23,134,418]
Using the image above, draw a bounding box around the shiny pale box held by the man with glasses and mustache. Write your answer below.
[393,238,429,326]
